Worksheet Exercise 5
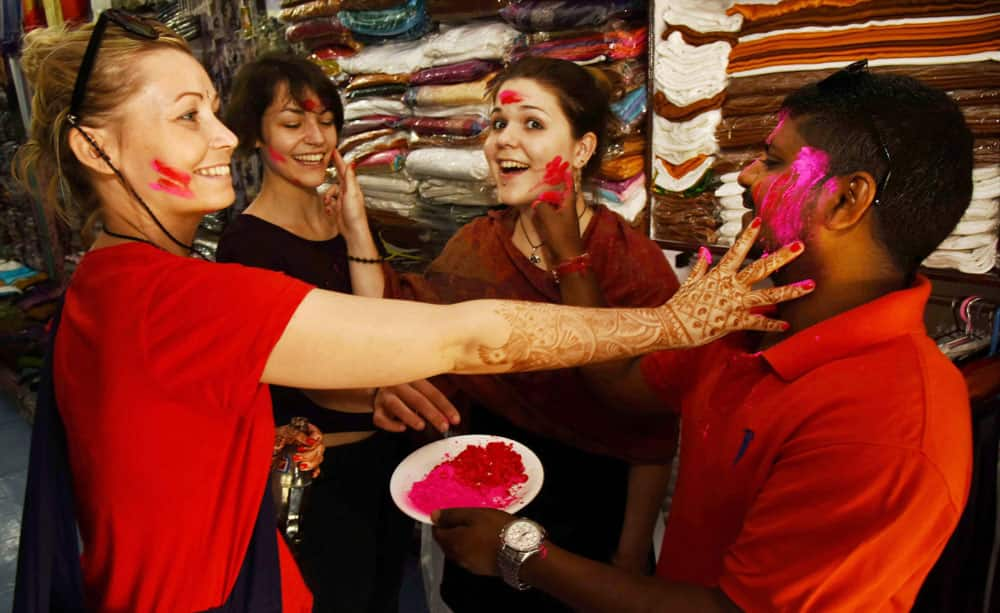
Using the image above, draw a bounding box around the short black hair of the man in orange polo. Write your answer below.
[782,67,973,274]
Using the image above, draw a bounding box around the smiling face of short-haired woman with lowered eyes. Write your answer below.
[257,83,337,188]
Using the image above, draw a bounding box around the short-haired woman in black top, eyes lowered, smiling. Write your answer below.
[217,55,412,613]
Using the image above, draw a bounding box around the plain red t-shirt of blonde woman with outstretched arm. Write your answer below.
[55,243,312,612]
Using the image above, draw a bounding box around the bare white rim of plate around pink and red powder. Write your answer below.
[389,434,545,524]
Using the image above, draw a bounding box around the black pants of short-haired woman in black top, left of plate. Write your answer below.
[296,432,413,613]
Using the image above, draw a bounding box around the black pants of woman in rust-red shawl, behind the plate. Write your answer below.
[441,407,628,613]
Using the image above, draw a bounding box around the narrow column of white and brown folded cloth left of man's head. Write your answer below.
[652,0,742,243]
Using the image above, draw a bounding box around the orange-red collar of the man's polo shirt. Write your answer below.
[761,275,931,381]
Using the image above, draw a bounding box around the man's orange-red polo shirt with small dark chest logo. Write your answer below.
[642,277,972,611]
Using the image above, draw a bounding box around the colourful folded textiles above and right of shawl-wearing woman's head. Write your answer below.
[500,0,648,222]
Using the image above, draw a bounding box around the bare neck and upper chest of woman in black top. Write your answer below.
[245,172,340,240]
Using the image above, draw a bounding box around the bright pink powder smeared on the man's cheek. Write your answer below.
[754,146,830,249]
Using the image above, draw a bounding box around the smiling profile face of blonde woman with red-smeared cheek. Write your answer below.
[109,49,236,214]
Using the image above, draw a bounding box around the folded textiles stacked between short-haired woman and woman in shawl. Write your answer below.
[289,16,518,263]
